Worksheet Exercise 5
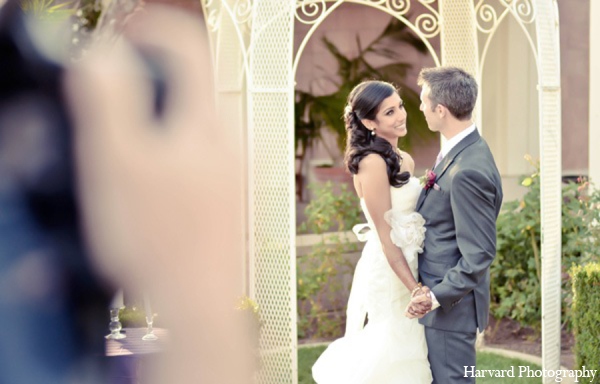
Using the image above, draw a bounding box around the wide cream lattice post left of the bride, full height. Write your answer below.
[248,0,297,384]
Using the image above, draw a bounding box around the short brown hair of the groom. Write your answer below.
[417,67,477,120]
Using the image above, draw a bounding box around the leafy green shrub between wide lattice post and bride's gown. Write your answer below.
[297,182,361,338]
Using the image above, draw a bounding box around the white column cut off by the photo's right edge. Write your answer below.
[588,1,600,188]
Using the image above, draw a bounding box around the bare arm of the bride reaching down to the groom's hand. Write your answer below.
[356,154,418,292]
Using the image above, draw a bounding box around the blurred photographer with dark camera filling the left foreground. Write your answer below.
[0,1,253,383]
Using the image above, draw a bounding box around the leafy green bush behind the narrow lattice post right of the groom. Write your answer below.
[490,156,600,331]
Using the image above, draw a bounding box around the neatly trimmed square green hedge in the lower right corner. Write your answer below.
[570,263,600,369]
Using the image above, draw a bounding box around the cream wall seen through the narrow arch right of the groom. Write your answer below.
[480,16,539,201]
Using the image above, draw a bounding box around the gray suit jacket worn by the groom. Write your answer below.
[417,130,502,332]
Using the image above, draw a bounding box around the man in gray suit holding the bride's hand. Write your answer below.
[407,67,502,384]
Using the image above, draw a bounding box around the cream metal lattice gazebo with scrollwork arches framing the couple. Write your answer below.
[201,0,561,384]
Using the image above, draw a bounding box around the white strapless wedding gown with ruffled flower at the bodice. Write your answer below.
[312,177,432,384]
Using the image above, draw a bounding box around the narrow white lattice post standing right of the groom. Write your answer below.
[535,0,562,383]
